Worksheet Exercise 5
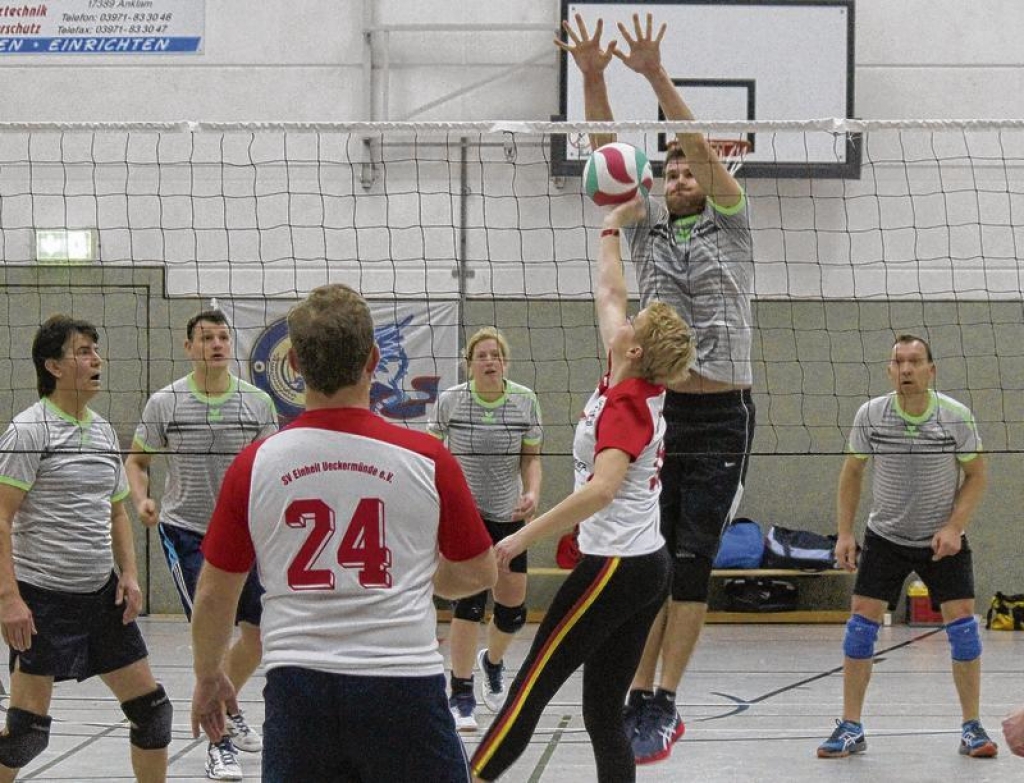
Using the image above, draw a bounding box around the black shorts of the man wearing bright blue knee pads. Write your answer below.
[853,530,974,608]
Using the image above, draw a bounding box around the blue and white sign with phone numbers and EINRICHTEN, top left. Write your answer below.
[0,0,206,54]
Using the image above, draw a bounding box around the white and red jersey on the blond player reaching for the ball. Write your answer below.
[572,376,666,557]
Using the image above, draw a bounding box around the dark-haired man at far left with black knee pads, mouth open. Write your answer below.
[0,315,173,783]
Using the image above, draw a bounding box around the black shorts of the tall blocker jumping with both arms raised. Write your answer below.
[660,389,755,562]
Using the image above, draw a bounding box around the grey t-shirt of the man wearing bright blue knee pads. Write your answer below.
[847,390,982,547]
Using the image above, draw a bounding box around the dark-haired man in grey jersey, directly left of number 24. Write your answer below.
[126,309,278,780]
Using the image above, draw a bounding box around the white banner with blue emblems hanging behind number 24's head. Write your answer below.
[230,299,459,429]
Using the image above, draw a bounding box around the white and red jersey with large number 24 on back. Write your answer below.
[203,407,490,677]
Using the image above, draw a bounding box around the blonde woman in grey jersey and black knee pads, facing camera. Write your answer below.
[429,328,542,732]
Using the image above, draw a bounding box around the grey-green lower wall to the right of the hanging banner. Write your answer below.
[465,301,1024,610]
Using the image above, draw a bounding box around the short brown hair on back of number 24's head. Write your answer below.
[288,284,374,394]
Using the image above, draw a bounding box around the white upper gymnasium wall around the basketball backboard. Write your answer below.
[0,0,1024,298]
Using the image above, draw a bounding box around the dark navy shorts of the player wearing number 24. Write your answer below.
[262,666,469,783]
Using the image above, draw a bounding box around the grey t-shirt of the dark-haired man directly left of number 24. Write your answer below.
[135,374,278,535]
